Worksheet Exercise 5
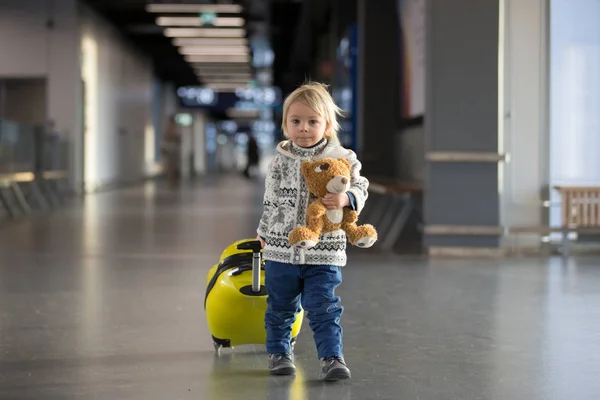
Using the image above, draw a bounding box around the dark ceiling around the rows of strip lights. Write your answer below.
[83,0,312,90]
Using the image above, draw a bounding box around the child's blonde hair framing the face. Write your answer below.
[281,82,343,142]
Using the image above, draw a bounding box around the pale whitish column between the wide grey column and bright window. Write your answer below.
[499,0,549,247]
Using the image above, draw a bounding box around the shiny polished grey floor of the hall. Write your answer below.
[0,177,600,400]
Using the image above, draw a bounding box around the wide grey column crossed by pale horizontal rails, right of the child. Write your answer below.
[424,0,499,247]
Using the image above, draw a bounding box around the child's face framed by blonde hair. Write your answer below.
[285,101,329,147]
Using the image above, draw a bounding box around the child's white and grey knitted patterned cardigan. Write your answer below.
[257,140,369,266]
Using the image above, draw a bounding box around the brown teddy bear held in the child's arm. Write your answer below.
[289,157,377,249]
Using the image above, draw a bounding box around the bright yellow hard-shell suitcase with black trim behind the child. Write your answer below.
[204,239,304,352]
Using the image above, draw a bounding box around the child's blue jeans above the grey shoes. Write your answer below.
[265,261,344,358]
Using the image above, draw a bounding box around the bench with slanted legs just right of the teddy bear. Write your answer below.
[359,176,423,251]
